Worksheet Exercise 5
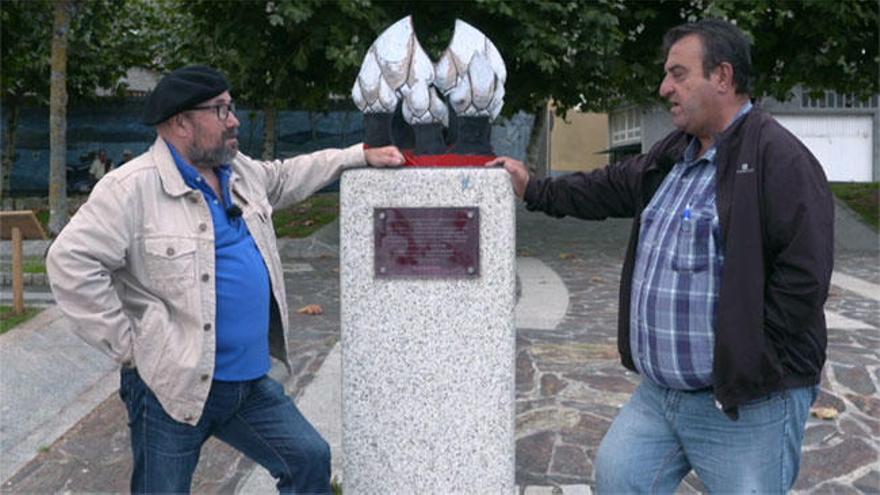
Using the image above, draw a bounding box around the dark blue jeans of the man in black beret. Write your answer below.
[119,369,330,494]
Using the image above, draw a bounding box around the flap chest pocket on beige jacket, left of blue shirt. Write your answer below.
[144,237,196,293]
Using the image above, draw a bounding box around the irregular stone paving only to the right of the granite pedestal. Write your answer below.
[517,213,880,494]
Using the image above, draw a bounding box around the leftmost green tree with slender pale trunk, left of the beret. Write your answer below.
[0,0,164,219]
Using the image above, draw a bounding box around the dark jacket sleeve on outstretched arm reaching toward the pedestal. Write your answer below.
[523,155,648,220]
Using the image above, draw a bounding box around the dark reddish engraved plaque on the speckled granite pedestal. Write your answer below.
[373,207,480,278]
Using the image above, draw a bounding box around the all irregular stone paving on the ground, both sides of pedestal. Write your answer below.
[0,203,880,494]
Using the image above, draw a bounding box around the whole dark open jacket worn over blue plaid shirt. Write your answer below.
[525,108,834,418]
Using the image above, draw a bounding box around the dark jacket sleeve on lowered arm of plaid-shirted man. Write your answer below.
[762,128,834,372]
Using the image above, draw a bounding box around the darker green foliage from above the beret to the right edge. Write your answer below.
[170,0,880,113]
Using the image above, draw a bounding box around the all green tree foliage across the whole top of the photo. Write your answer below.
[0,0,880,199]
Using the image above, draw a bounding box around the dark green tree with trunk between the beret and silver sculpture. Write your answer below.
[167,0,383,158]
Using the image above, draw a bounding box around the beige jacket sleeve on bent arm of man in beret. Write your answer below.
[46,177,132,362]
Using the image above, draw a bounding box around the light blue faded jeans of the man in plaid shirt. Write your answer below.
[596,379,818,494]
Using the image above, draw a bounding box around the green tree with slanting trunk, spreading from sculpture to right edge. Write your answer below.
[376,0,880,173]
